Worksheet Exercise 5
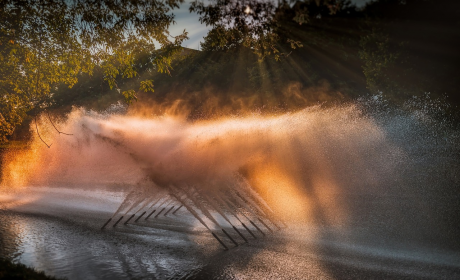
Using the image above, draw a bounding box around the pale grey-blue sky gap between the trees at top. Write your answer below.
[169,0,370,49]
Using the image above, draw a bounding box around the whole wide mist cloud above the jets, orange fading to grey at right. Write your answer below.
[2,96,460,249]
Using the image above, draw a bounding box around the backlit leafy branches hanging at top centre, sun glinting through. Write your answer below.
[190,0,349,61]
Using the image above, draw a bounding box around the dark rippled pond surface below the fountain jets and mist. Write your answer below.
[0,187,460,279]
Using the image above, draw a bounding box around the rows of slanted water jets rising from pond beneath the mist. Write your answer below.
[101,174,281,250]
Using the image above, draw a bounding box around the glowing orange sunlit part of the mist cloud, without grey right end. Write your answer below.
[2,103,398,234]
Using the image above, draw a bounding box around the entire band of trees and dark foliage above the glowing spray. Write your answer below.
[0,0,460,141]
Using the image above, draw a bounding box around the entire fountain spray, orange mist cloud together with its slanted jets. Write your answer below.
[12,97,458,256]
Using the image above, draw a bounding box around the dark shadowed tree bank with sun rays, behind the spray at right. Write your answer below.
[147,0,460,116]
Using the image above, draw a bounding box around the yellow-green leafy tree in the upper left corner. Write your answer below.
[0,0,187,142]
